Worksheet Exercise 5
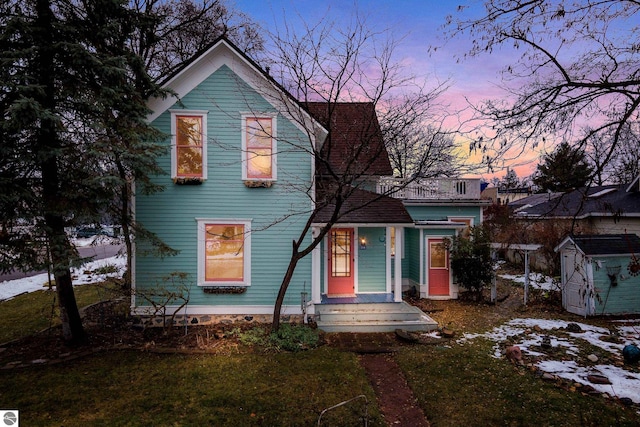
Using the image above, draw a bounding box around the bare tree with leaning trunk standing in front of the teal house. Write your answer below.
[262,14,452,331]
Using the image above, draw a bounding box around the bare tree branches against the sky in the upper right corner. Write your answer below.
[448,0,640,174]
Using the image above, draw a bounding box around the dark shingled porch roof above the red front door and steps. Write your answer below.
[314,188,413,224]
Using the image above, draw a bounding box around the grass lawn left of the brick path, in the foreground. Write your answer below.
[0,347,383,426]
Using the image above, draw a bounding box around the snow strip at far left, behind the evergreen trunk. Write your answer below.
[0,256,127,301]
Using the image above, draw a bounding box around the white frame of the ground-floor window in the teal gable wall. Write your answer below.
[196,218,251,287]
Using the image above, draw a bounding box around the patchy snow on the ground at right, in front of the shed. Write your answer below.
[458,319,640,404]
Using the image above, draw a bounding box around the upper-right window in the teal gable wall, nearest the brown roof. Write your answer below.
[242,115,276,181]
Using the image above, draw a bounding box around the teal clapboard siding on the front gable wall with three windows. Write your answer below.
[135,66,312,306]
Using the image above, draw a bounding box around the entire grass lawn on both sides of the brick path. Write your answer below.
[0,286,640,427]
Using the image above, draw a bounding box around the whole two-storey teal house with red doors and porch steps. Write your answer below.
[132,38,482,331]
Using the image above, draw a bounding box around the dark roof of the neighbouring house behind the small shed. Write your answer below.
[516,185,640,219]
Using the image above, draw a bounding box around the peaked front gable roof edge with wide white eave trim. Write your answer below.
[147,36,327,143]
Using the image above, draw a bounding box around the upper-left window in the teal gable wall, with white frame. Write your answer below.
[171,111,207,180]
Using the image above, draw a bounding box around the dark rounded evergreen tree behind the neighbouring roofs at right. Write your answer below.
[533,142,593,192]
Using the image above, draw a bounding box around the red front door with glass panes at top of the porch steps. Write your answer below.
[327,228,355,296]
